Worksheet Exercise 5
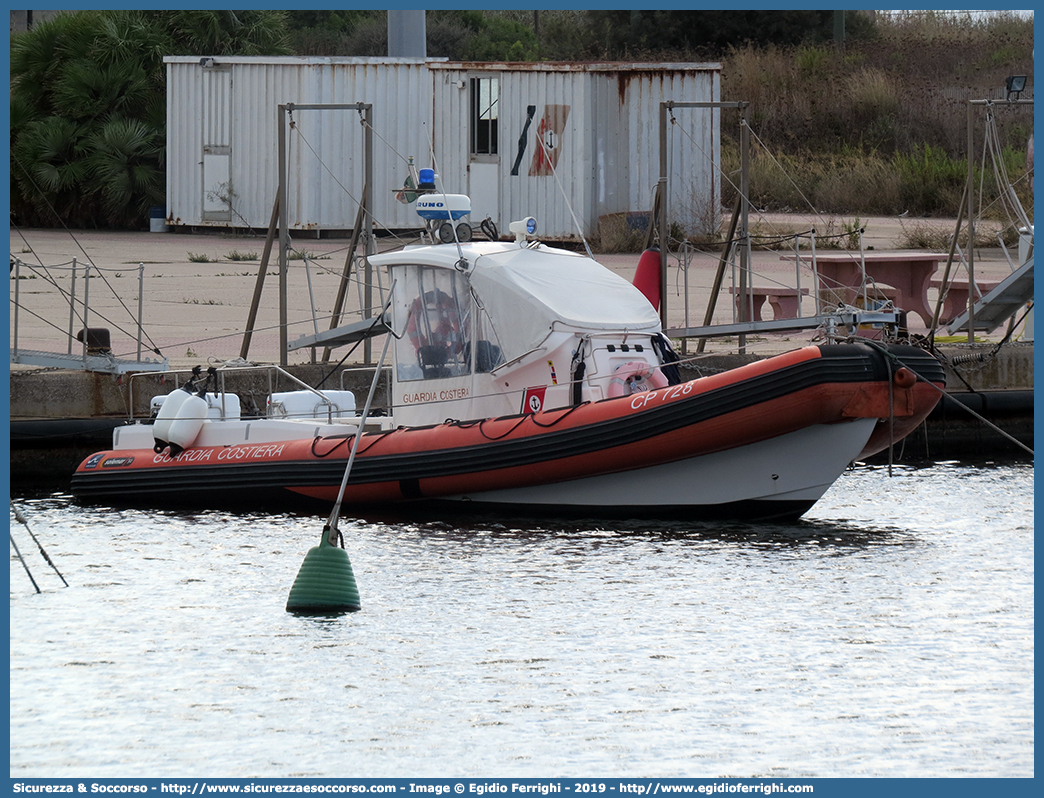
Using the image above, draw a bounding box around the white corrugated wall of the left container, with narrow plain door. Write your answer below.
[164,56,432,231]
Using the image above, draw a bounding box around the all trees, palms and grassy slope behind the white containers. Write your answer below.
[10,9,1034,227]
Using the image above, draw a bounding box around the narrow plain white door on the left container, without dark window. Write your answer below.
[200,67,234,221]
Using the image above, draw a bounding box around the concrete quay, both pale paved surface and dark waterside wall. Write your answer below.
[10,217,1034,480]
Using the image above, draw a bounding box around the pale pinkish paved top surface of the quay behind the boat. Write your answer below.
[10,214,1014,368]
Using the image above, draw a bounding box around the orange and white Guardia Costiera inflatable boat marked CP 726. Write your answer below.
[72,227,944,519]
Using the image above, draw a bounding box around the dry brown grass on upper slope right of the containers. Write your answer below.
[721,13,1034,172]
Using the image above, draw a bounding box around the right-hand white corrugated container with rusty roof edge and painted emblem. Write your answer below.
[431,63,720,240]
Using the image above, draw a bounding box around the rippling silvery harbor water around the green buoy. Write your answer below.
[10,463,1035,778]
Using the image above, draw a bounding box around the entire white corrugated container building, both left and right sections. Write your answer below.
[164,56,720,239]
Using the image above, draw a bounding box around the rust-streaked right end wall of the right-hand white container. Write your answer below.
[590,64,722,238]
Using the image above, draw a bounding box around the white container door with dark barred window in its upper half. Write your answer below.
[468,74,503,231]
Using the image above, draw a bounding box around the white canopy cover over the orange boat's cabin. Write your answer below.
[371,242,660,361]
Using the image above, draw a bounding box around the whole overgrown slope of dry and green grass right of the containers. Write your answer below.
[721,13,1034,216]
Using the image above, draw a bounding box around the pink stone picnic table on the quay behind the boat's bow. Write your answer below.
[782,252,946,326]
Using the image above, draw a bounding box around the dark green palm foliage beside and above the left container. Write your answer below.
[10,10,290,228]
